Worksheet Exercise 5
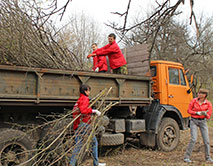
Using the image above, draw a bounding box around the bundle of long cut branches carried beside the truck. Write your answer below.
[14,88,117,166]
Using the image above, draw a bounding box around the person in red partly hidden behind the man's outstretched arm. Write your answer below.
[92,43,108,73]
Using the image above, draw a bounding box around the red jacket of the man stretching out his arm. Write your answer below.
[93,41,126,69]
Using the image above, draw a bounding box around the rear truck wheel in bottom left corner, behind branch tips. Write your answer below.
[0,129,33,166]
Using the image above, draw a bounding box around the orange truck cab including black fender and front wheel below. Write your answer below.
[138,60,193,151]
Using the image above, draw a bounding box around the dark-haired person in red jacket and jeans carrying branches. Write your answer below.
[70,84,106,166]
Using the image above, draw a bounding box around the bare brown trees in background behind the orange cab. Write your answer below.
[123,9,213,96]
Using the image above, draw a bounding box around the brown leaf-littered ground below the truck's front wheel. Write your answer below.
[83,127,213,166]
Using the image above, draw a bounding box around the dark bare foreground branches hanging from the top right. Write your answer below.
[106,0,199,51]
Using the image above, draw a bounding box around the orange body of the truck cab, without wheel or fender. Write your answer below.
[150,61,193,118]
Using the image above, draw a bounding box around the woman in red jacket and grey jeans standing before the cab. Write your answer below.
[184,89,213,163]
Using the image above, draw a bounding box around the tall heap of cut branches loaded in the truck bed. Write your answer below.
[0,0,83,70]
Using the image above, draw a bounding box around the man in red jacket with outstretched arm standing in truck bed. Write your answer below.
[87,33,128,74]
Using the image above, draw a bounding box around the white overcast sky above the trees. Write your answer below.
[56,0,213,27]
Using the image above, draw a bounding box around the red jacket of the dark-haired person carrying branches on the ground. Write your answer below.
[73,94,92,130]
